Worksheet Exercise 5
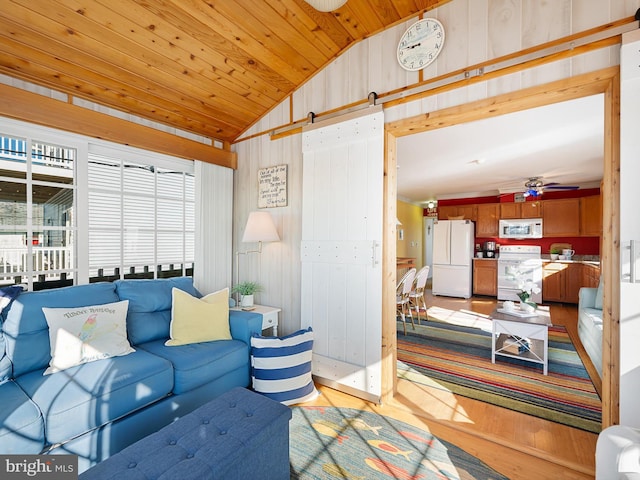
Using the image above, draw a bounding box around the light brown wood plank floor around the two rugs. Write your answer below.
[305,294,600,480]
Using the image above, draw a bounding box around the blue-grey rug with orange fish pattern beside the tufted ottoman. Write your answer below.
[289,407,507,480]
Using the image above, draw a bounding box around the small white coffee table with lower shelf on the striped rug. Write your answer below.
[489,307,552,375]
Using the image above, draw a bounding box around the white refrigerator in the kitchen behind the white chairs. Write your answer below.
[432,220,475,298]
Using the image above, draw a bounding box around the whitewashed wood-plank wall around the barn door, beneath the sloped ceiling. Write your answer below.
[233,0,638,333]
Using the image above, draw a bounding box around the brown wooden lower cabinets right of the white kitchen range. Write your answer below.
[542,262,600,303]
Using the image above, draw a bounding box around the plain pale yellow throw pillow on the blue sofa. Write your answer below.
[165,287,231,347]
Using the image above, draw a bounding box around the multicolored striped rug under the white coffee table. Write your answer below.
[398,309,601,433]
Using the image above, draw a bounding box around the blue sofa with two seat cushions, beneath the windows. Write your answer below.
[0,277,262,471]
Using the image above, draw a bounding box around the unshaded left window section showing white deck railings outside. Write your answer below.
[0,135,76,290]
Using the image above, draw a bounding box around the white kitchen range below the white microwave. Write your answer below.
[498,245,542,304]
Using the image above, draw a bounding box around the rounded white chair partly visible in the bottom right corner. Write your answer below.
[596,425,640,480]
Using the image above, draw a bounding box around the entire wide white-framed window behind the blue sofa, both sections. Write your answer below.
[0,119,195,290]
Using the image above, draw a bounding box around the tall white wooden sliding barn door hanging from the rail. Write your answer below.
[301,107,384,403]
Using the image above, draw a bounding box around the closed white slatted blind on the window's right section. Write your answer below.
[88,152,195,277]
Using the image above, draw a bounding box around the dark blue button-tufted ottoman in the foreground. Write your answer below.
[79,387,291,480]
